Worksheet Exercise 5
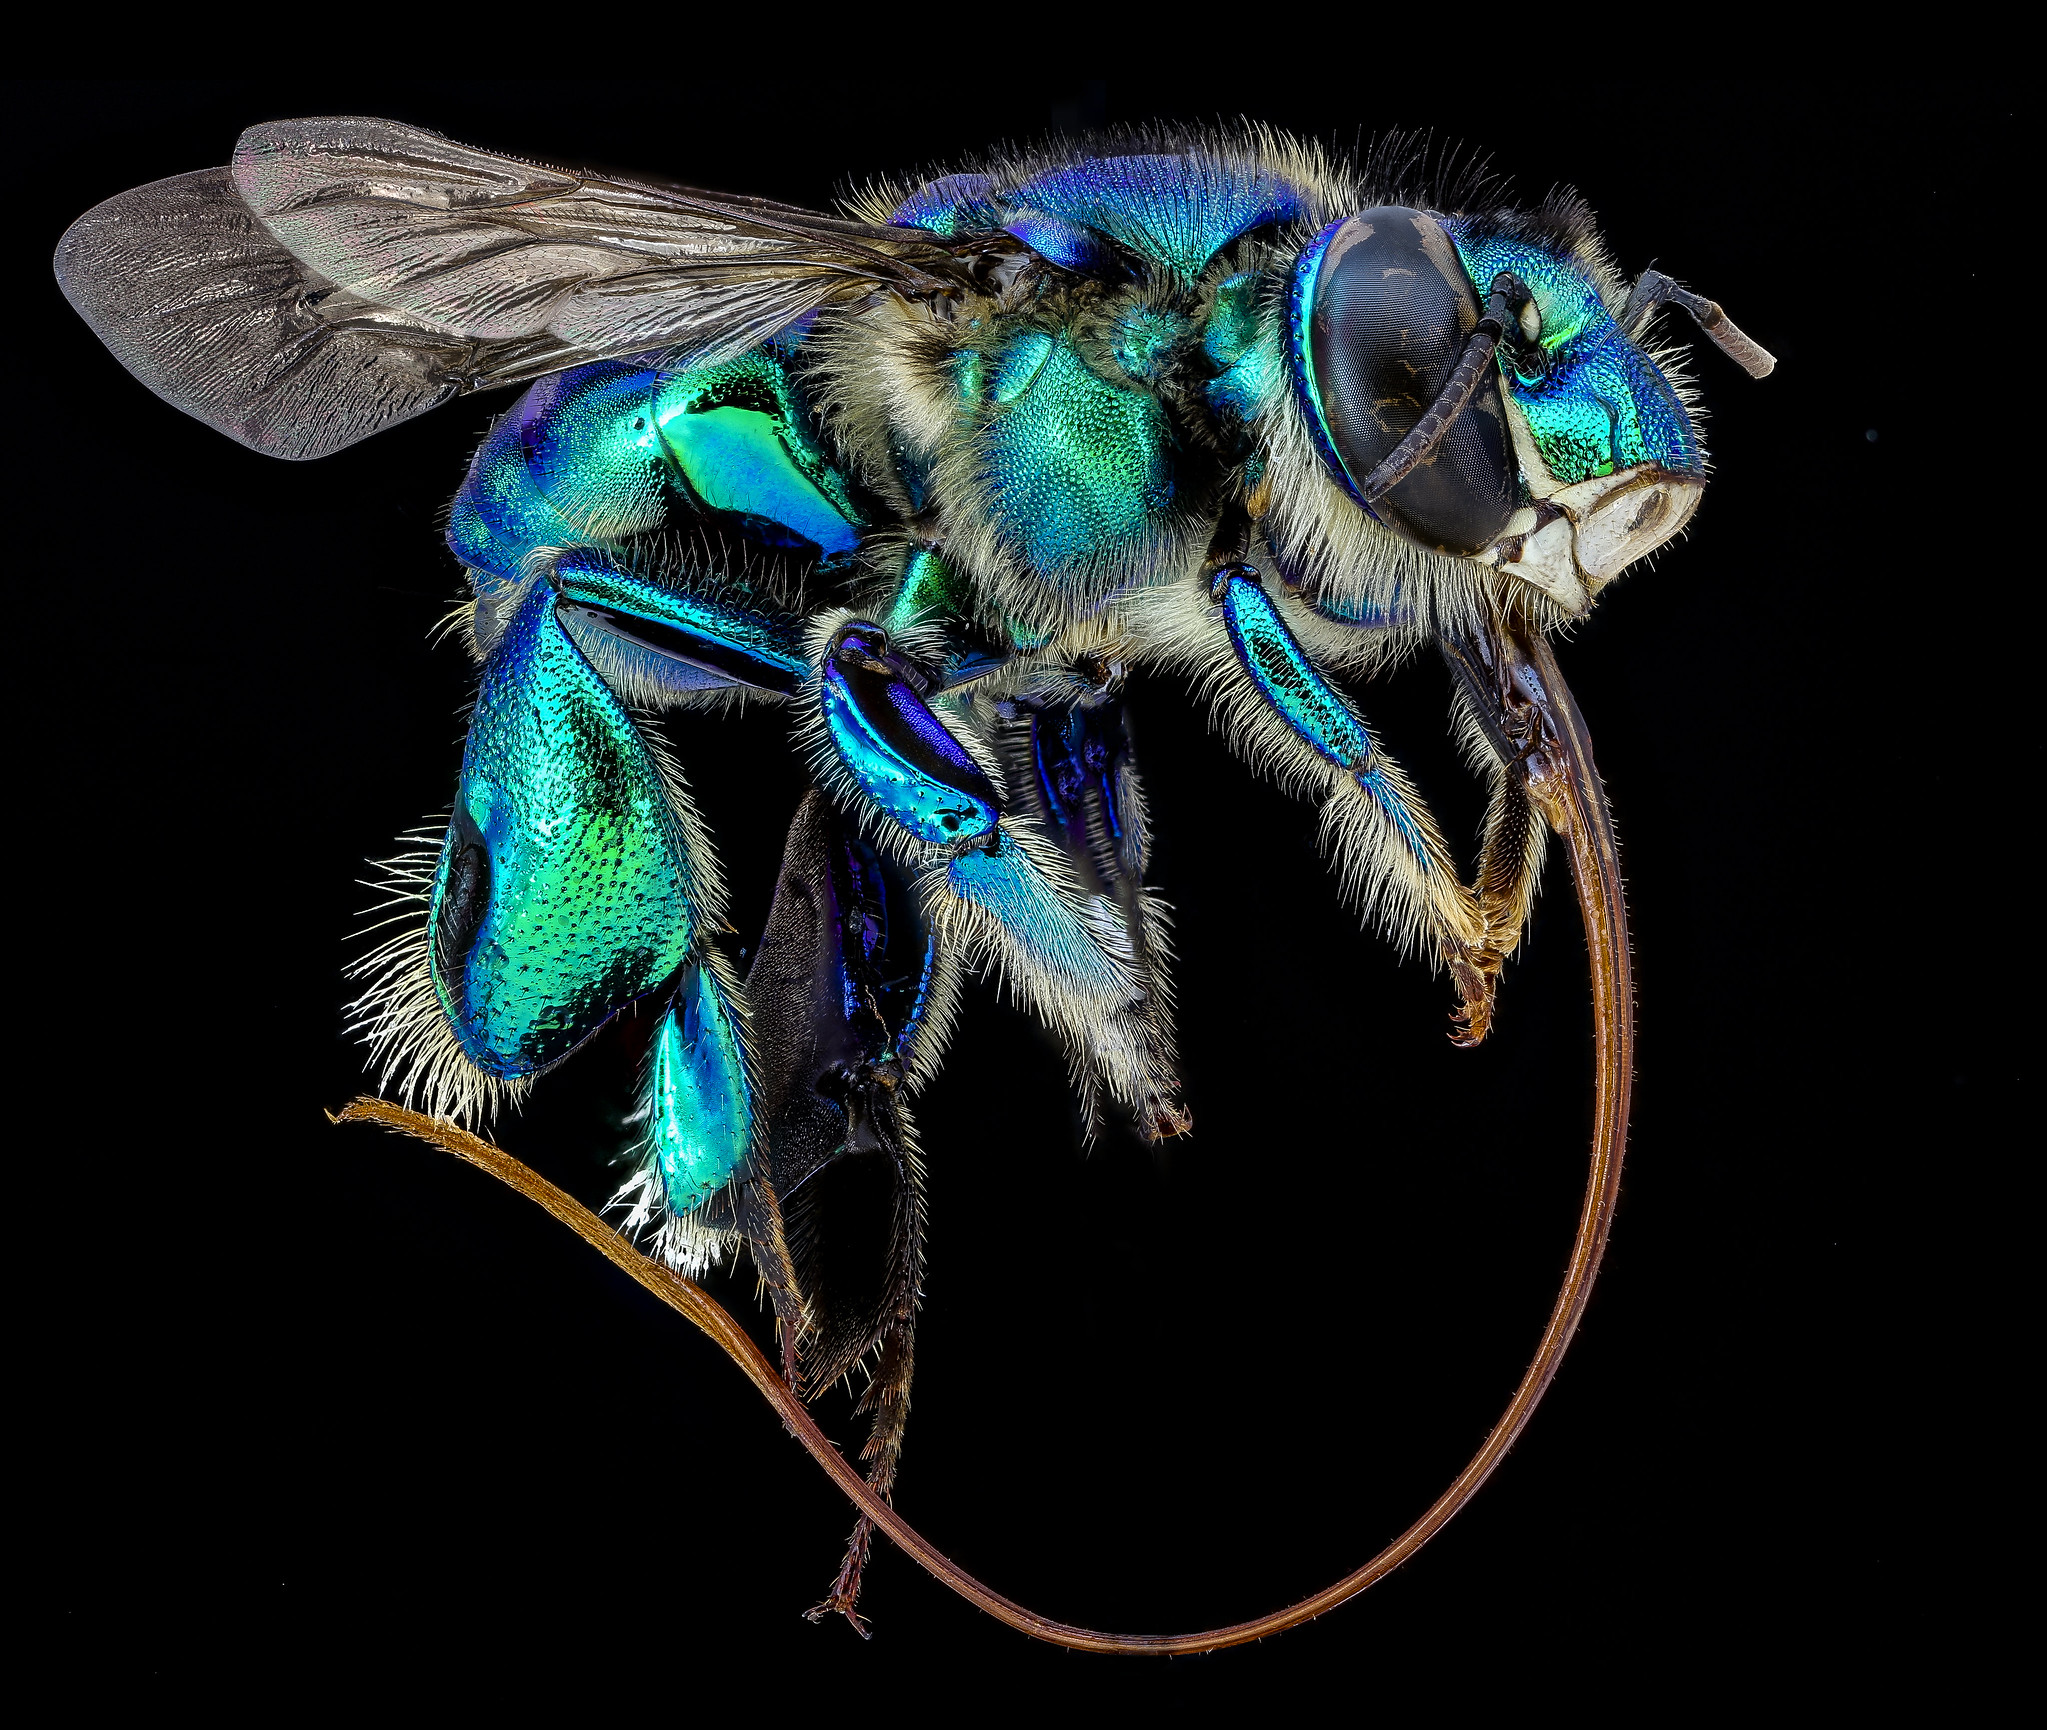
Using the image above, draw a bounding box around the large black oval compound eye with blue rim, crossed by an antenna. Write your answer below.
[1292,205,1519,553]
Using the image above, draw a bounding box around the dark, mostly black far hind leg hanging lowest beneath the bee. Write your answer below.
[747,792,952,1626]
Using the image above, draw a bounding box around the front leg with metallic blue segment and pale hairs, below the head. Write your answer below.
[1150,563,1490,1005]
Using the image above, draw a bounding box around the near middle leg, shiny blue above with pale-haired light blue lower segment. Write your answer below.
[802,612,1152,1112]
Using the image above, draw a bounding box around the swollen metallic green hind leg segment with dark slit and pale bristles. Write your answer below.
[356,573,723,1116]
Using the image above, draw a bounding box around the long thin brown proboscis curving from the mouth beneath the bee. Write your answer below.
[338,633,1634,1656]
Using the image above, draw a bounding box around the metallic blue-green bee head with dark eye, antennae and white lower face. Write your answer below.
[1288,205,1775,612]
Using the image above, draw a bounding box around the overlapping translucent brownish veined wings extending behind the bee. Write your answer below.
[57,119,944,459]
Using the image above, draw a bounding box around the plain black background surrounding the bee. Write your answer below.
[8,77,2006,1716]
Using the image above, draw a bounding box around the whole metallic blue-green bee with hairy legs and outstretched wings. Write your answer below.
[57,119,1771,1644]
